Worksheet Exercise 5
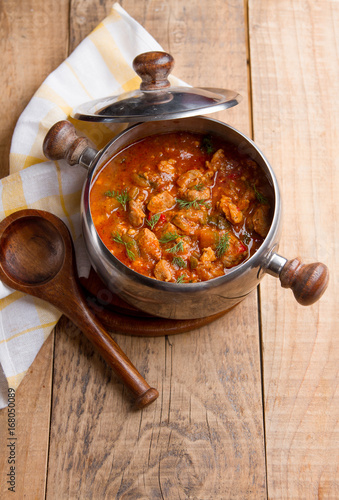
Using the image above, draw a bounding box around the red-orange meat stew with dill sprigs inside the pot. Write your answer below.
[90,132,272,283]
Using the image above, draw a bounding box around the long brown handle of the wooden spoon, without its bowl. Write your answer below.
[53,281,159,409]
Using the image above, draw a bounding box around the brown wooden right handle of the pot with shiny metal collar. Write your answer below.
[266,253,329,306]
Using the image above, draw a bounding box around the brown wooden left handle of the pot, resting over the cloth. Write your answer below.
[42,120,97,168]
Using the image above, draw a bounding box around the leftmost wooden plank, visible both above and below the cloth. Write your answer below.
[0,0,68,499]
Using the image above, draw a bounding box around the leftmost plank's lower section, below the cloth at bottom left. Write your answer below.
[0,334,54,500]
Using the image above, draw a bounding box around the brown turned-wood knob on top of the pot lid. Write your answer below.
[133,52,174,90]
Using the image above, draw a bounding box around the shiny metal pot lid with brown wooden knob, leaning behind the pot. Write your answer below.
[72,52,241,123]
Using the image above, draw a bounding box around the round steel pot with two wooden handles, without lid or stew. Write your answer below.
[45,117,328,319]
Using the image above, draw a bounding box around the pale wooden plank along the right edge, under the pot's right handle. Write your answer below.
[249,0,339,499]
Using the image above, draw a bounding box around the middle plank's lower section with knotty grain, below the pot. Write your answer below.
[47,298,266,499]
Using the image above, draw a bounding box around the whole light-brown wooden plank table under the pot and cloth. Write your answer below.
[0,0,339,500]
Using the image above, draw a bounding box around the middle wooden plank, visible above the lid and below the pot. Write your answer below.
[47,0,266,500]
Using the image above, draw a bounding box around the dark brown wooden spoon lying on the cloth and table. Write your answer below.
[0,209,159,408]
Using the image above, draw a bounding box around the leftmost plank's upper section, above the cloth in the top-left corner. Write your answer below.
[0,0,68,177]
